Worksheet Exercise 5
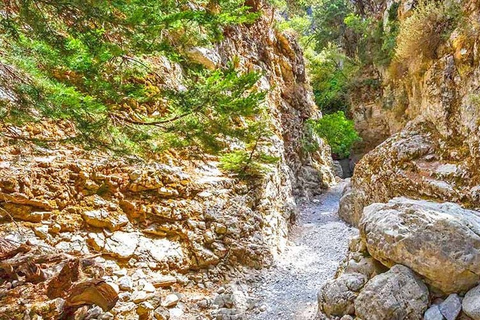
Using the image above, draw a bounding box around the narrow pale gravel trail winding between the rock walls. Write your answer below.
[249,182,358,320]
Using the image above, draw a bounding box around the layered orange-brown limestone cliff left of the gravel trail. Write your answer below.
[0,3,334,319]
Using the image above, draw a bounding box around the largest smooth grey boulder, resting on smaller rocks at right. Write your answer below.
[360,198,480,293]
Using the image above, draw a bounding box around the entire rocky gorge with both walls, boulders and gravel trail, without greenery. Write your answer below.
[0,0,480,320]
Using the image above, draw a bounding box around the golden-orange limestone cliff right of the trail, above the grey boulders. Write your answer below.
[343,1,480,223]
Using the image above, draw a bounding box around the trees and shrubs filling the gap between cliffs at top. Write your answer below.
[272,0,398,114]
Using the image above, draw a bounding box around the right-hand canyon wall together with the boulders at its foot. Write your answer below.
[318,0,480,320]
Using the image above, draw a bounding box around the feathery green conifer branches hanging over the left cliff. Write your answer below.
[0,0,274,174]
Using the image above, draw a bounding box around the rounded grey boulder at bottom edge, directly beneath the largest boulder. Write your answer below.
[355,265,429,320]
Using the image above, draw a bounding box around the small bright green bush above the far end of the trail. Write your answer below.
[312,111,360,158]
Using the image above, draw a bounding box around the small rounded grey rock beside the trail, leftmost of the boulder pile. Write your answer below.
[318,273,367,317]
